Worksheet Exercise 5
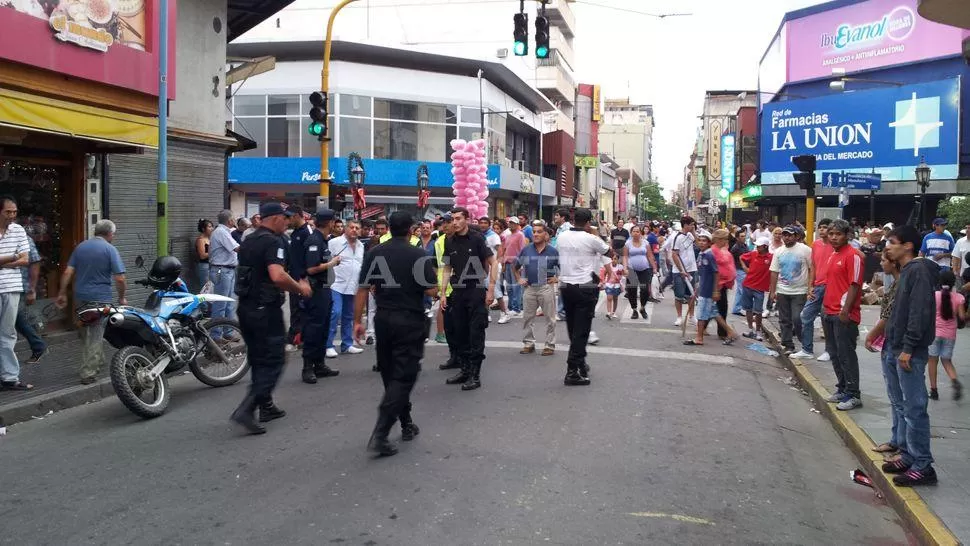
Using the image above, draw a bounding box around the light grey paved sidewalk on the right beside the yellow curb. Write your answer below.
[768,306,970,544]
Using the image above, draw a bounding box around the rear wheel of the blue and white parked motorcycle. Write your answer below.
[110,346,172,419]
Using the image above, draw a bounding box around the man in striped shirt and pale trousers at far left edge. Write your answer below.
[0,196,34,391]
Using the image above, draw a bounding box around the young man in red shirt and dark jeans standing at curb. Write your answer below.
[822,220,864,411]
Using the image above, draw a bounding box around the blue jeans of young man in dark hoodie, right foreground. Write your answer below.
[883,347,933,471]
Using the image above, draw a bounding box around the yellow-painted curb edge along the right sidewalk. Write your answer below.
[763,324,961,546]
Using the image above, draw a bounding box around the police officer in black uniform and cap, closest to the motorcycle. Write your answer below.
[231,203,312,434]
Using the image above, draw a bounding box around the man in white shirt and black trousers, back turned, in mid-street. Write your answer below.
[557,209,610,385]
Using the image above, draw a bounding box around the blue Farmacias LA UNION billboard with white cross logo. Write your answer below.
[761,78,960,184]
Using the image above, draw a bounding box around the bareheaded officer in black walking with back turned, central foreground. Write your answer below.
[354,211,438,456]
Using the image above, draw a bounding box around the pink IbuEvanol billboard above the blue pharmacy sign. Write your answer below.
[784,0,965,83]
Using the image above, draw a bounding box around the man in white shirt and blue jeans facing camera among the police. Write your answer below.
[327,220,364,358]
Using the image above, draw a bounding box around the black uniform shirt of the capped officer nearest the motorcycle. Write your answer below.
[236,223,286,305]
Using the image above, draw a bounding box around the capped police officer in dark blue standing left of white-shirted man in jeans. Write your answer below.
[302,209,340,384]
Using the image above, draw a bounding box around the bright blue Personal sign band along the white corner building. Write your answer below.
[229,157,501,190]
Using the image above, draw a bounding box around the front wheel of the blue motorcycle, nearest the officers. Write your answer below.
[189,318,249,387]
